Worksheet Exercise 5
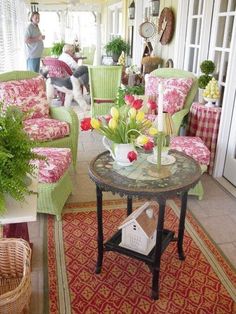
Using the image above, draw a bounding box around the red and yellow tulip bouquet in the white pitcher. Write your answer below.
[81,95,158,158]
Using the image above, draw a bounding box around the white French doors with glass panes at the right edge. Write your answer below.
[184,0,236,185]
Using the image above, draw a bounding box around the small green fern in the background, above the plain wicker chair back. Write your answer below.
[105,37,130,62]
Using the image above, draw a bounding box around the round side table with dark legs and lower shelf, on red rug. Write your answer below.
[89,151,201,299]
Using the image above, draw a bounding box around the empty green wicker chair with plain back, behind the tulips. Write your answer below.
[88,65,122,117]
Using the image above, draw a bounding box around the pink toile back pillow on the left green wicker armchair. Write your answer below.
[0,77,49,119]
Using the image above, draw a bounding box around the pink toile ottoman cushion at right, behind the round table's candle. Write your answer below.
[170,136,210,166]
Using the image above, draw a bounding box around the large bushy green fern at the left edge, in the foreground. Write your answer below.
[0,102,38,214]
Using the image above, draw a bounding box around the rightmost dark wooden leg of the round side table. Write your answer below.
[177,191,188,261]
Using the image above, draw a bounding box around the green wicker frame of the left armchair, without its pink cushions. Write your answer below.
[0,71,79,167]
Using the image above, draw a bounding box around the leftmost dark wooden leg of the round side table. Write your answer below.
[95,186,103,274]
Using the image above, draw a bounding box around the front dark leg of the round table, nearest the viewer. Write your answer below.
[152,199,166,300]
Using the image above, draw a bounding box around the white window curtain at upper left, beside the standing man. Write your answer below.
[0,0,28,72]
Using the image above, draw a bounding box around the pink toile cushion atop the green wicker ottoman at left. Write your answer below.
[32,147,72,183]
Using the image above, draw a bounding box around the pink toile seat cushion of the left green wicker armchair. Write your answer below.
[24,118,70,142]
